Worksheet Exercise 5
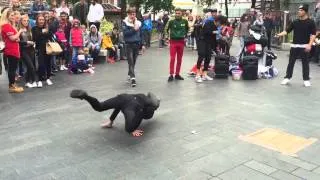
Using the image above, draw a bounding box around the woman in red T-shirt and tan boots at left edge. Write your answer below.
[0,9,23,93]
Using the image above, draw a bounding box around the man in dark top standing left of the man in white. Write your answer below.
[72,0,89,26]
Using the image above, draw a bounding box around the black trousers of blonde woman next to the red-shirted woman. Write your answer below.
[21,47,36,82]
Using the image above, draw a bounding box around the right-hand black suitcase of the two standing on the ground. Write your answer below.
[242,56,259,80]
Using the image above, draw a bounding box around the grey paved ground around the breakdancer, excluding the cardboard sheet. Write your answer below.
[0,39,320,180]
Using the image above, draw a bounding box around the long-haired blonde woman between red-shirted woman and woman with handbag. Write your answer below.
[20,14,37,88]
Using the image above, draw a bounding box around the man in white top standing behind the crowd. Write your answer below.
[87,0,104,31]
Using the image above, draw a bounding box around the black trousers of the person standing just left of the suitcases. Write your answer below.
[197,40,213,71]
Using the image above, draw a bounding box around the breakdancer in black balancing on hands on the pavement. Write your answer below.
[70,90,160,137]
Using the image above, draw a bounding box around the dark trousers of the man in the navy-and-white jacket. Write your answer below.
[126,43,139,78]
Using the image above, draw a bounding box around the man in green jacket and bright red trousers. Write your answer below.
[165,8,189,82]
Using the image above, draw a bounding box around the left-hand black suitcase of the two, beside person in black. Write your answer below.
[214,54,230,78]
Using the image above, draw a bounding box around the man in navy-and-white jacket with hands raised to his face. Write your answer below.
[122,7,144,87]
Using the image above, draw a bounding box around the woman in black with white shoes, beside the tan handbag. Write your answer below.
[32,14,53,88]
